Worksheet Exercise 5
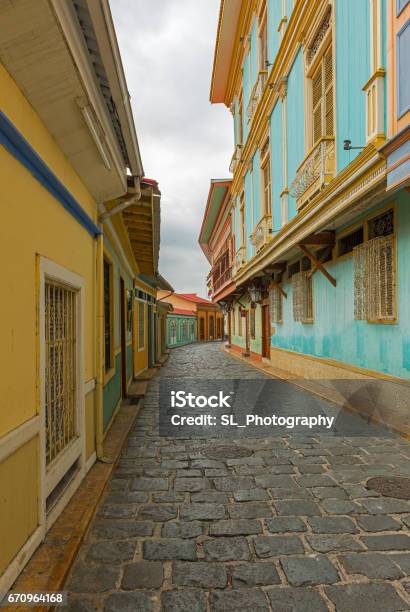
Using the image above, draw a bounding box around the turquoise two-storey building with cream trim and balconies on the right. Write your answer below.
[208,0,410,380]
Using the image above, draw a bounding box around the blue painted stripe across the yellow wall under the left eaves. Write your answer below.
[0,111,102,238]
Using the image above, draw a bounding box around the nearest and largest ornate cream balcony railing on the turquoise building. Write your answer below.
[289,136,335,209]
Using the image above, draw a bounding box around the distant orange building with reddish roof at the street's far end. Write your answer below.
[158,291,224,346]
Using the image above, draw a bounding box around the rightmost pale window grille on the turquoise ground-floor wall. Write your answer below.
[353,236,396,321]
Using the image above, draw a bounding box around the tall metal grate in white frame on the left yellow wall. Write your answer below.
[45,281,76,464]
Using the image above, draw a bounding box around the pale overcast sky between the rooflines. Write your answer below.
[111,0,233,297]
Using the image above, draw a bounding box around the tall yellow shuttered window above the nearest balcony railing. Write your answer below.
[312,45,334,145]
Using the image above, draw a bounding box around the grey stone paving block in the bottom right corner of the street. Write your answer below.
[325,582,409,612]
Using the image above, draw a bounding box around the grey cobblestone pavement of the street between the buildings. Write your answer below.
[66,344,410,612]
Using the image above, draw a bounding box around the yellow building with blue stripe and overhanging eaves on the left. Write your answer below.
[0,0,167,591]
